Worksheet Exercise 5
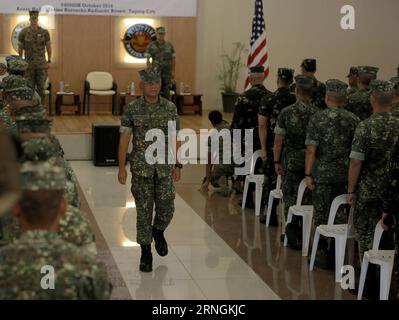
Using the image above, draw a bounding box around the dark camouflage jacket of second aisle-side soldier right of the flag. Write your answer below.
[259,87,296,150]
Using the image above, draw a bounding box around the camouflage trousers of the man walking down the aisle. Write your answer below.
[131,173,175,245]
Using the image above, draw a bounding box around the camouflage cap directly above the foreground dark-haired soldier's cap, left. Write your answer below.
[22,137,58,162]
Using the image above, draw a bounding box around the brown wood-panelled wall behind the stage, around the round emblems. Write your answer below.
[0,14,197,112]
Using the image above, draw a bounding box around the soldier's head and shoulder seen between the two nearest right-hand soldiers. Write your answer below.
[345,66,379,121]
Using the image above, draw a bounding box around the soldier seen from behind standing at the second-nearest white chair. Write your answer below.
[305,79,359,227]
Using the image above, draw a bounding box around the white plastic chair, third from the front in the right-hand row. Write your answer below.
[284,179,314,257]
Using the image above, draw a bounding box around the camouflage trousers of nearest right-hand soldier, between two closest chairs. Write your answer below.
[353,197,381,255]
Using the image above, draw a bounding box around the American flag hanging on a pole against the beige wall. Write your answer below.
[245,0,269,90]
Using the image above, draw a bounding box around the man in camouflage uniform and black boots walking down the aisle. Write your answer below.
[118,68,181,272]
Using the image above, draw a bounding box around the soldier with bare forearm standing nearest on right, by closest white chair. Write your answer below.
[348,80,399,253]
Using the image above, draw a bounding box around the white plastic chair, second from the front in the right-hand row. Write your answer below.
[309,194,353,282]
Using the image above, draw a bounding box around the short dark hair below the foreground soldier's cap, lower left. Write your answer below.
[19,190,63,226]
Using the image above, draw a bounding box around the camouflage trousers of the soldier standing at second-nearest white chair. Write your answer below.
[312,182,348,227]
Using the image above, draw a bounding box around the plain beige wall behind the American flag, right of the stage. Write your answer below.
[196,0,399,109]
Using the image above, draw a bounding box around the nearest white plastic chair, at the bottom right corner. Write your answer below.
[357,222,395,300]
